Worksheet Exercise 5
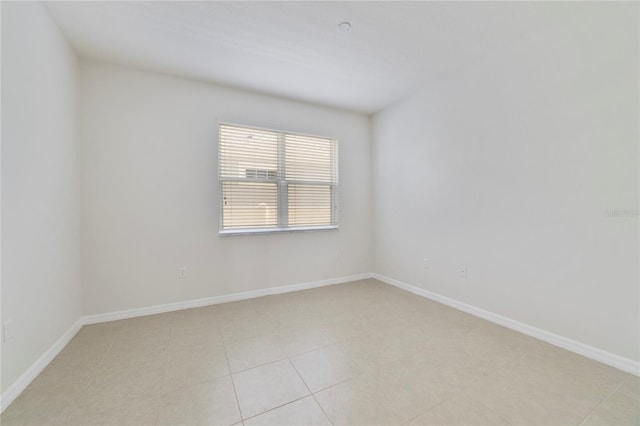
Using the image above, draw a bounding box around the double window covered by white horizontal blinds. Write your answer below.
[218,124,338,234]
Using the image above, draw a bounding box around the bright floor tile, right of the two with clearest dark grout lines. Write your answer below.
[291,344,360,392]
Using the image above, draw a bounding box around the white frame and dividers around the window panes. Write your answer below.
[217,121,340,236]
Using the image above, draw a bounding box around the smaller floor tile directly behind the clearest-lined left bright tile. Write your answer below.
[225,335,286,372]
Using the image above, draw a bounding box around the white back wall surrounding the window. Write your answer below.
[80,60,372,315]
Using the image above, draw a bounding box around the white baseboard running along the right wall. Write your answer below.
[372,274,640,376]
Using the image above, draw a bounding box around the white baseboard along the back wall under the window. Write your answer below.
[83,273,373,324]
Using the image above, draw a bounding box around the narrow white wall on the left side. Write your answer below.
[1,2,82,392]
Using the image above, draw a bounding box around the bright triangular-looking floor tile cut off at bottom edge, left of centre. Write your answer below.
[244,396,331,426]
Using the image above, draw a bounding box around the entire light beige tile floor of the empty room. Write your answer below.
[0,280,640,426]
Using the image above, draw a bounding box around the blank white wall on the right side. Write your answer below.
[372,3,640,361]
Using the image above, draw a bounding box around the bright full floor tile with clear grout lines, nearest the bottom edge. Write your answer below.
[233,359,309,419]
